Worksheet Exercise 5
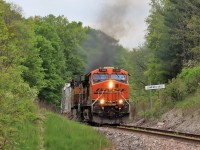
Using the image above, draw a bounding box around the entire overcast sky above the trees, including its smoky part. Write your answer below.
[6,0,150,49]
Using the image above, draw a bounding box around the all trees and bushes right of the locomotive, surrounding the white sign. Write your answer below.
[128,0,200,117]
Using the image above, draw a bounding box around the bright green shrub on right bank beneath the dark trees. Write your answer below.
[161,66,200,110]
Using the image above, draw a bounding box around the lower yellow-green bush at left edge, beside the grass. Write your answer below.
[0,67,37,149]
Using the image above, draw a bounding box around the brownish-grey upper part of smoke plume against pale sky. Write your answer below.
[97,0,137,39]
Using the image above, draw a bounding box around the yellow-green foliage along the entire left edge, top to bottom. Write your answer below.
[0,1,37,149]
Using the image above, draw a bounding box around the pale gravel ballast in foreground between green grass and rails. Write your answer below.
[95,127,200,150]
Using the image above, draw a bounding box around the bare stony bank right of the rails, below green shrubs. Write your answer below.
[130,109,200,134]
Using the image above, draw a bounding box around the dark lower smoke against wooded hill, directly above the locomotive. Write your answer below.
[85,29,119,73]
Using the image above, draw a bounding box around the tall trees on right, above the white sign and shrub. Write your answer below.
[147,0,199,82]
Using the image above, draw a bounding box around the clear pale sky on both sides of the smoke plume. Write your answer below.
[5,0,150,49]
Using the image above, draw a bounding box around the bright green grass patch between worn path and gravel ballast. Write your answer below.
[44,112,110,150]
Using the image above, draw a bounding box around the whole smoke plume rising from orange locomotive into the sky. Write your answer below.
[83,0,140,72]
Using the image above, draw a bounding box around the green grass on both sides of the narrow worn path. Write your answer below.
[13,109,111,150]
